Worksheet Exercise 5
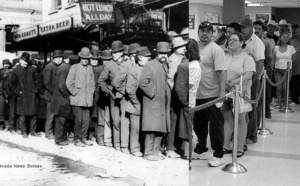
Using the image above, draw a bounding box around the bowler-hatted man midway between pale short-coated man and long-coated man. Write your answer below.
[98,40,131,153]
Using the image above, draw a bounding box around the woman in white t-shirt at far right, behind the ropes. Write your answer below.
[273,32,296,108]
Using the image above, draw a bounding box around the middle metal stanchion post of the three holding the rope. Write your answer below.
[257,70,273,135]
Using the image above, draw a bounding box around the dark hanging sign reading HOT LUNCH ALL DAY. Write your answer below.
[80,0,115,24]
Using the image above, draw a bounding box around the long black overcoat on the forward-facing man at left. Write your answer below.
[11,65,38,116]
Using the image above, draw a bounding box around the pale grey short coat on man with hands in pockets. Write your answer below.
[66,63,95,107]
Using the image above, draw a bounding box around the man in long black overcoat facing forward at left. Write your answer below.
[11,52,39,138]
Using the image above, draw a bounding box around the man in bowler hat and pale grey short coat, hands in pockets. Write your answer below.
[66,47,95,147]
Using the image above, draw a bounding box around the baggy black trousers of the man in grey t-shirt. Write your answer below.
[194,98,224,158]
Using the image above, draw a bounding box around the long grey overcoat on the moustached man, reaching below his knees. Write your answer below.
[139,59,171,133]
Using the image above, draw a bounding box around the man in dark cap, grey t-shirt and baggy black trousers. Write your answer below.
[194,21,227,167]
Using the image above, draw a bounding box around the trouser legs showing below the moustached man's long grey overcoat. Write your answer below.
[144,132,164,156]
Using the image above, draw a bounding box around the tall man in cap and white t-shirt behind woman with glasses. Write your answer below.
[240,18,265,144]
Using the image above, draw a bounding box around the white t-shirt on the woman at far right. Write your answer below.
[274,45,296,70]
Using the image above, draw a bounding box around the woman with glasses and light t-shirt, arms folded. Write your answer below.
[221,32,255,157]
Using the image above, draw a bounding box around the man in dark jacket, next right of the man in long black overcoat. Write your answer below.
[44,50,63,139]
